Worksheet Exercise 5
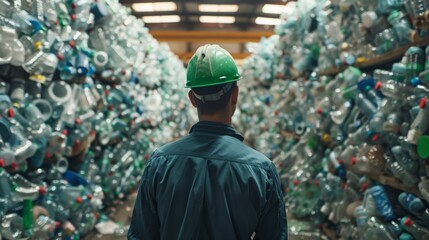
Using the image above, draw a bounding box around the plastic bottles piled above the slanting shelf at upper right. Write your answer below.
[275,0,429,77]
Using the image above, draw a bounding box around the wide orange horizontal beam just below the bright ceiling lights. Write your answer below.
[150,31,274,43]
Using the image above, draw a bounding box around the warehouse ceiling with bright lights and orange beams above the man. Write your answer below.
[120,0,294,61]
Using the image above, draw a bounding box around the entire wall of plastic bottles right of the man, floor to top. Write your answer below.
[234,0,429,239]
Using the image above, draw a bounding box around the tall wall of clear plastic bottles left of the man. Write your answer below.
[0,0,190,239]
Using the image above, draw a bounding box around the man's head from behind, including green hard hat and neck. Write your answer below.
[186,45,240,119]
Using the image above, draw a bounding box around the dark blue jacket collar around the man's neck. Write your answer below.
[189,121,244,141]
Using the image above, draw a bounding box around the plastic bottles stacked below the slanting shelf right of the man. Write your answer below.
[236,47,429,239]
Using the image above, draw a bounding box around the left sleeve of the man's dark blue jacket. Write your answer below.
[128,159,160,240]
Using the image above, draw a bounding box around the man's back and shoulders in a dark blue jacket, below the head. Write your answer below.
[129,122,287,239]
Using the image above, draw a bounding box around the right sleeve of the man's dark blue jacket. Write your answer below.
[255,163,288,240]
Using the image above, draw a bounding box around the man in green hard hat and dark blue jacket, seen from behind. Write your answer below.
[128,45,287,240]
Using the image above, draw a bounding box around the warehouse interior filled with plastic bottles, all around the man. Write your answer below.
[0,0,429,240]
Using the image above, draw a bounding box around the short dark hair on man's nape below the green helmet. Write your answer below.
[192,82,237,114]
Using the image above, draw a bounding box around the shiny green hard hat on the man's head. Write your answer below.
[186,44,241,88]
